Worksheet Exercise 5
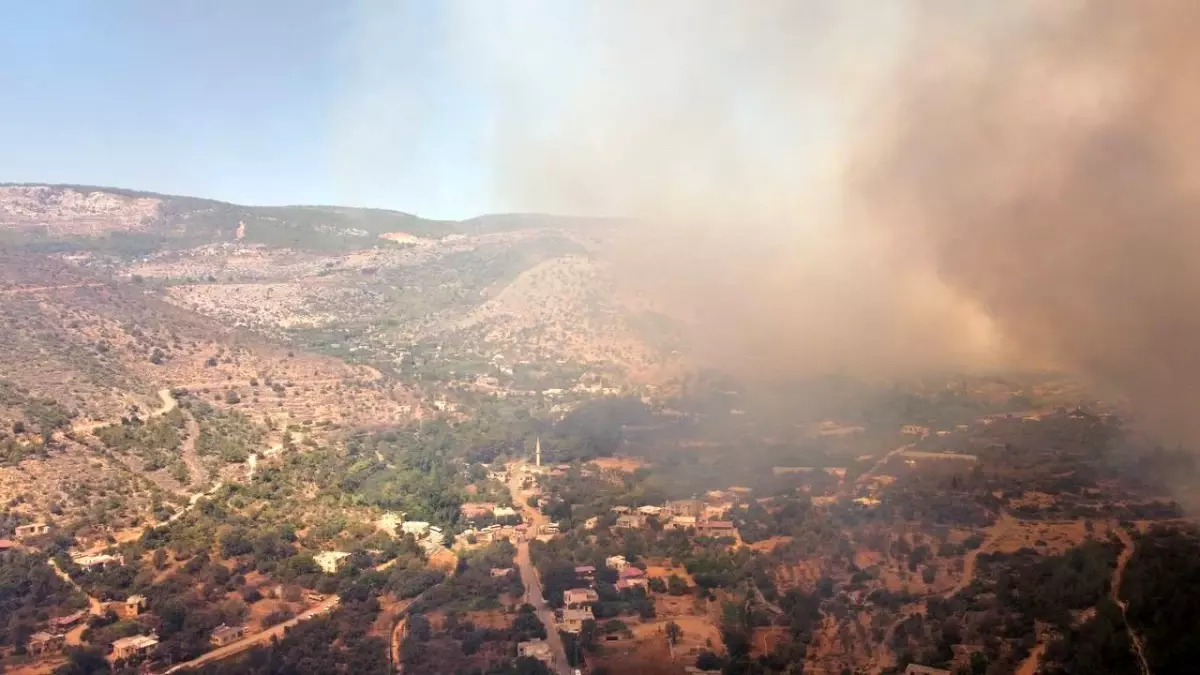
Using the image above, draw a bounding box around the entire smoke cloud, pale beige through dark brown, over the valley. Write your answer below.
[349,0,1200,438]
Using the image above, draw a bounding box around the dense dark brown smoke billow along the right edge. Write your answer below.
[860,0,1200,441]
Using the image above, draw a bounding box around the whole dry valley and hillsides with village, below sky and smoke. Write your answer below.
[0,181,1200,675]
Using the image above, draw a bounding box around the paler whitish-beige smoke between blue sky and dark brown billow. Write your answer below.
[436,0,988,377]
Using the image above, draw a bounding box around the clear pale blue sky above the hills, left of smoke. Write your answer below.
[0,0,496,217]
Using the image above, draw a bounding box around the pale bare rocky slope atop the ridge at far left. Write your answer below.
[0,185,162,237]
